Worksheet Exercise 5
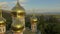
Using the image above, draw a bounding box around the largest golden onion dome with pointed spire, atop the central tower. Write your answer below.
[12,1,25,16]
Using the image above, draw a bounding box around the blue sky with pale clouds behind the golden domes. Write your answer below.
[0,0,60,13]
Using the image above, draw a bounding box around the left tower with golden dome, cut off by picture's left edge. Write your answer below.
[0,6,6,34]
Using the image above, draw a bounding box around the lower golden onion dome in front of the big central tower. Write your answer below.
[11,19,24,32]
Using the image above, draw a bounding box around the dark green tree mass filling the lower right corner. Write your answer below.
[38,16,60,34]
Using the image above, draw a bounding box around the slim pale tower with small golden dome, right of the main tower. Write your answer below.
[30,14,38,32]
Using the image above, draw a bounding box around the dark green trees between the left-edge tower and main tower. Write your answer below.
[3,12,12,30]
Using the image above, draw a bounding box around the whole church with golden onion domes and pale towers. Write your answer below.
[0,1,41,34]
